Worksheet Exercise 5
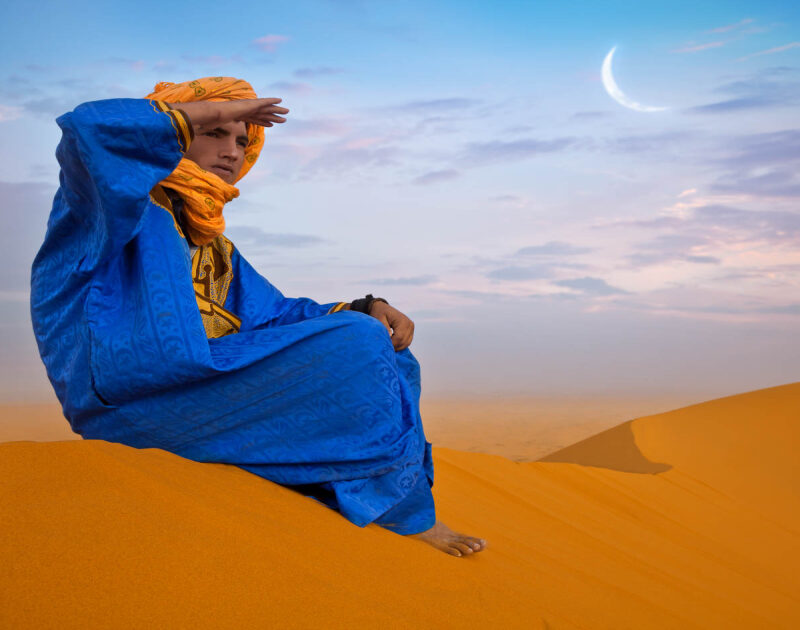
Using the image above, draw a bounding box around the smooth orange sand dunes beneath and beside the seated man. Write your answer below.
[0,383,800,629]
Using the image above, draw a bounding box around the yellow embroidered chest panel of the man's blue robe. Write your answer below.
[192,236,242,339]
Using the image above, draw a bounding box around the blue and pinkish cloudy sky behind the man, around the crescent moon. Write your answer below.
[0,0,800,401]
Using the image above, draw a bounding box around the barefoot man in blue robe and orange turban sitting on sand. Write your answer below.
[31,77,485,556]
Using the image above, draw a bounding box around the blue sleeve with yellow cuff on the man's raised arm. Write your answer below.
[50,99,192,271]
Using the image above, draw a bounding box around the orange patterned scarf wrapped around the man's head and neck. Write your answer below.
[147,77,264,245]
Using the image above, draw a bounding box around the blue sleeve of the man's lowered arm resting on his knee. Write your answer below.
[225,248,338,330]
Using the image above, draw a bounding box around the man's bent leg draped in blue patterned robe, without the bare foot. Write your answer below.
[82,313,433,531]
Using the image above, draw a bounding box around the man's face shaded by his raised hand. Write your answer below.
[185,121,248,184]
